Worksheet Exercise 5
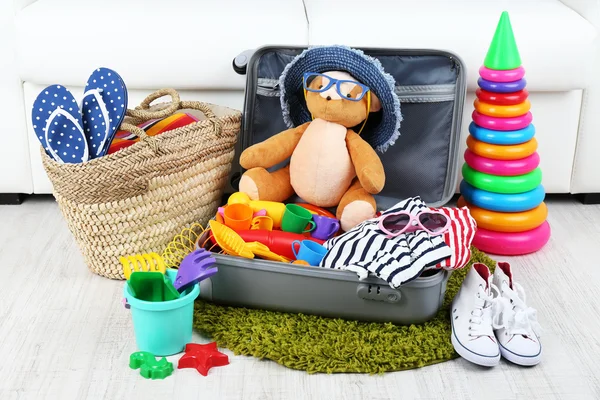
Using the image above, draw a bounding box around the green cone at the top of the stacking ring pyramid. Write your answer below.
[483,11,521,70]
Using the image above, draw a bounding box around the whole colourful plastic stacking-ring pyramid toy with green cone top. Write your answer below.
[458,12,550,255]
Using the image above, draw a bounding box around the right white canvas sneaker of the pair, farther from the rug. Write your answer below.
[493,263,542,366]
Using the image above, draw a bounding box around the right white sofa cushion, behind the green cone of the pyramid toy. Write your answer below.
[305,0,598,91]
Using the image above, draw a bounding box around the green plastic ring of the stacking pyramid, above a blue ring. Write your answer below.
[462,164,542,194]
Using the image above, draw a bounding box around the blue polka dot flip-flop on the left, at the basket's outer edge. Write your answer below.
[31,85,89,164]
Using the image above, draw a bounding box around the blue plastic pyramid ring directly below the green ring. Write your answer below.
[460,180,546,212]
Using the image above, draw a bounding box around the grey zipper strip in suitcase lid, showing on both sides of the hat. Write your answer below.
[256,78,456,103]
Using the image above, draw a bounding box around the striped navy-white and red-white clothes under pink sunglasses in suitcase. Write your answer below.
[320,197,475,288]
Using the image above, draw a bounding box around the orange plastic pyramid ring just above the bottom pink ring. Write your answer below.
[457,196,548,232]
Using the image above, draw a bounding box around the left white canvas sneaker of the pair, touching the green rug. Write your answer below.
[450,263,500,367]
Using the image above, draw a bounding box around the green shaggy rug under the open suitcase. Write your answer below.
[194,249,495,374]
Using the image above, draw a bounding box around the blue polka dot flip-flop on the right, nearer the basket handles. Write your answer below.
[81,68,127,159]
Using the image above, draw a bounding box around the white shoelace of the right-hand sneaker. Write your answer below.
[493,282,542,338]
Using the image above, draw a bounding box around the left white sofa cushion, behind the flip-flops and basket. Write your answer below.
[16,0,308,89]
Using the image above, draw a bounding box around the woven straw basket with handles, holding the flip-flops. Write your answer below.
[41,89,241,279]
